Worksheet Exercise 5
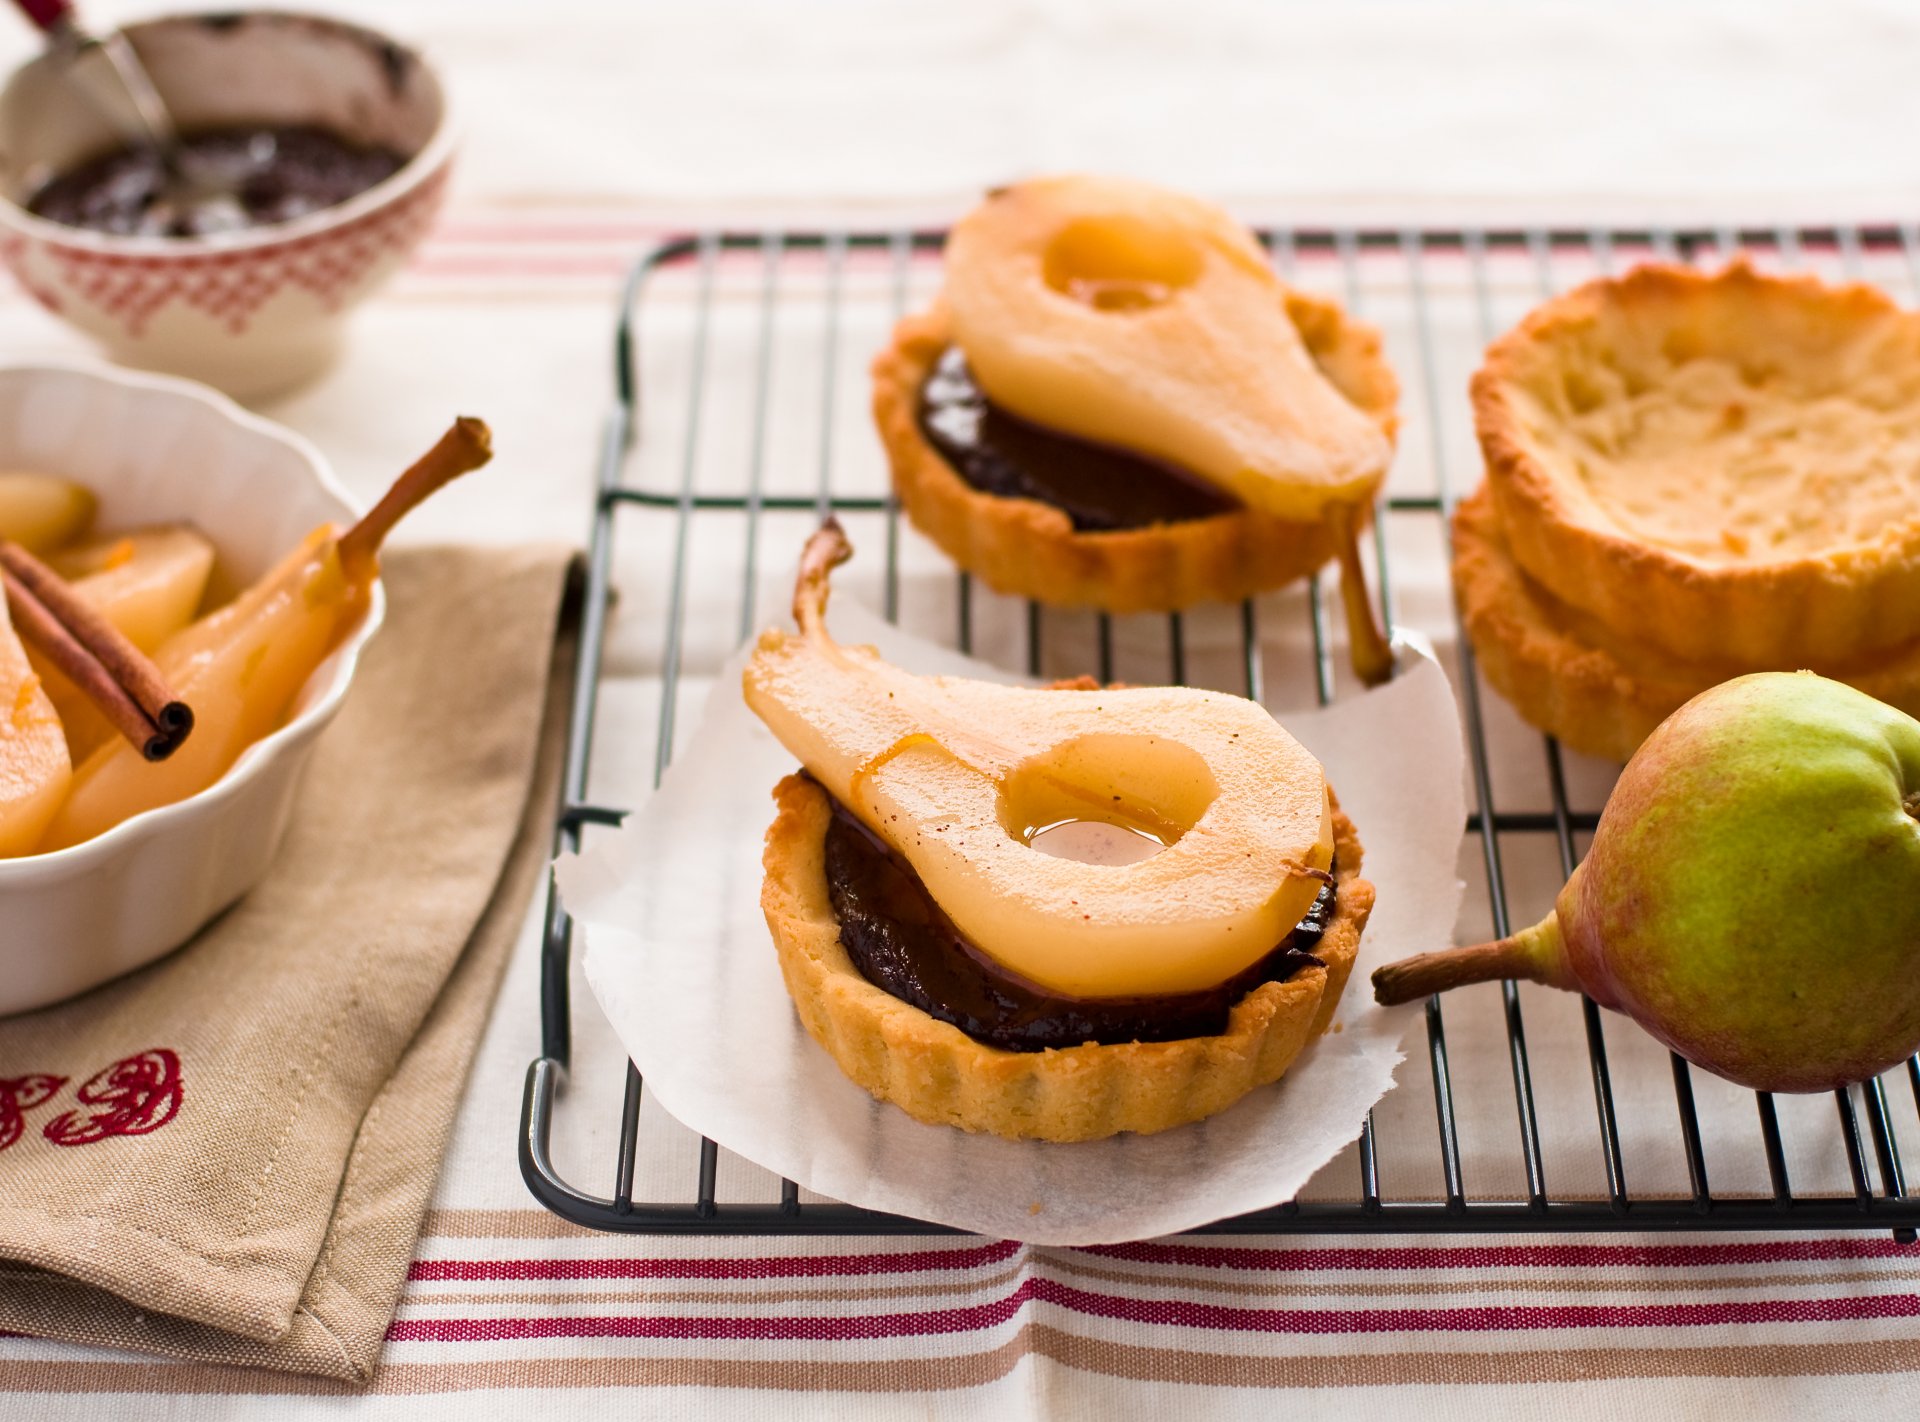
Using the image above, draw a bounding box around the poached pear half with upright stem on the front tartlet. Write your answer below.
[745,522,1332,998]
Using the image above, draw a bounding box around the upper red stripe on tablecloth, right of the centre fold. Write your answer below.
[1081,1240,1920,1272]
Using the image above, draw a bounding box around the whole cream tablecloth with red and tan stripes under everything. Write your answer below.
[11,0,1920,1422]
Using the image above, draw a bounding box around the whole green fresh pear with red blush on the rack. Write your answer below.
[1373,672,1920,1092]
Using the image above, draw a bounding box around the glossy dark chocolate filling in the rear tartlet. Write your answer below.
[920,345,1240,533]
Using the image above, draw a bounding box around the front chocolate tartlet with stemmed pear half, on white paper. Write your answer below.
[745,522,1373,1142]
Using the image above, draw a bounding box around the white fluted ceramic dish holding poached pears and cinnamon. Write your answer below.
[0,365,386,1013]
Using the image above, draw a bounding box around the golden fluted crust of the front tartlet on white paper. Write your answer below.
[760,775,1373,1140]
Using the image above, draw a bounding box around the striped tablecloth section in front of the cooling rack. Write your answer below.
[15,1209,1920,1422]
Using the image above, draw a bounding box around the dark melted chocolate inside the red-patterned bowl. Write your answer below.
[27,123,407,238]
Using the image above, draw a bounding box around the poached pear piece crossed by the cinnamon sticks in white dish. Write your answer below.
[27,524,213,764]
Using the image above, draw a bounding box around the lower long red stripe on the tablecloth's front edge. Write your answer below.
[386,1278,1920,1343]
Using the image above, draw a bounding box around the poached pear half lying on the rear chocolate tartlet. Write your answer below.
[945,177,1392,520]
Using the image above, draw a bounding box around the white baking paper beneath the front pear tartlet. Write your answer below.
[557,599,1463,1245]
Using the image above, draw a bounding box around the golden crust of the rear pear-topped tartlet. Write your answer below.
[874,290,1400,612]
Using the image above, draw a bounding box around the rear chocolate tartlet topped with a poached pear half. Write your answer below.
[874,177,1400,612]
